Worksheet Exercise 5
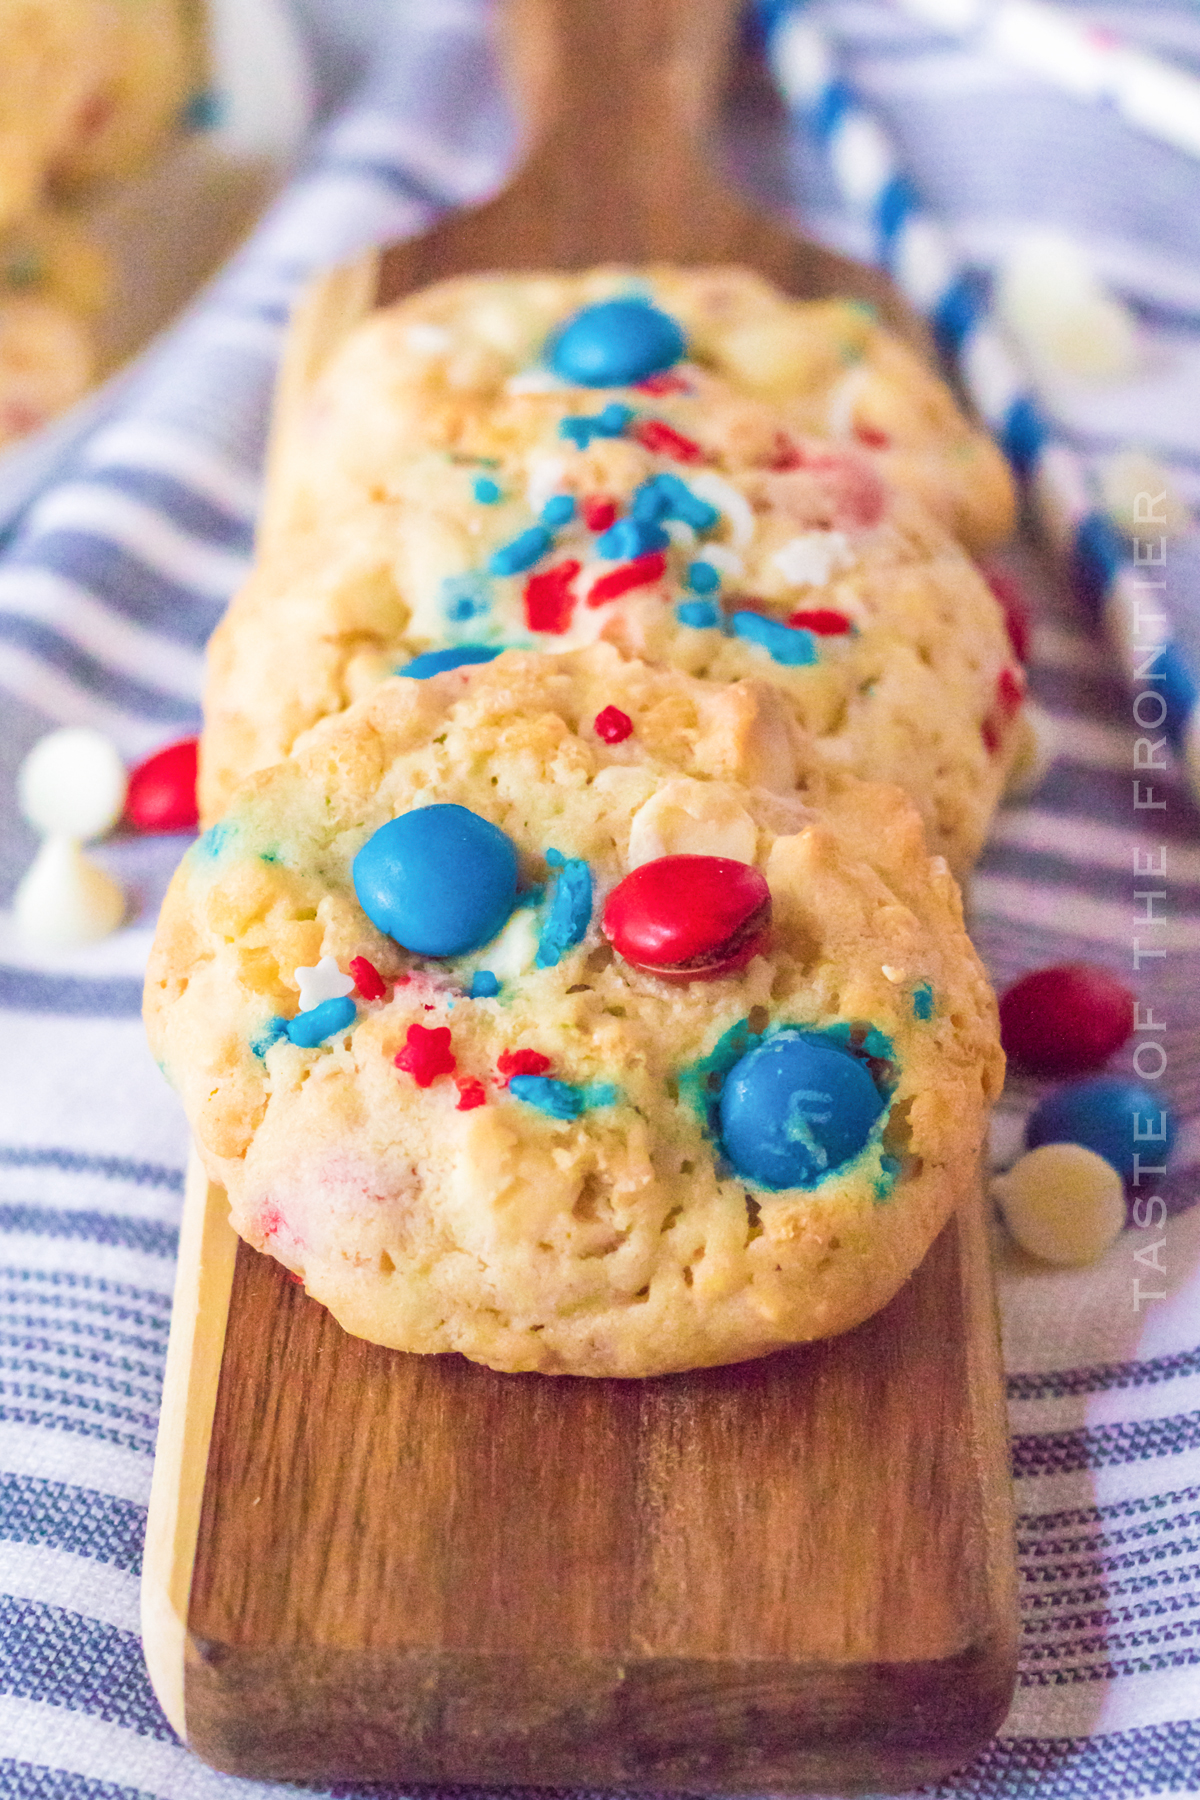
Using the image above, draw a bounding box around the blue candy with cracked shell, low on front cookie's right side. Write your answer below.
[720,1031,883,1188]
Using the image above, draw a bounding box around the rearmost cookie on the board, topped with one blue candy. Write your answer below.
[287,266,1015,553]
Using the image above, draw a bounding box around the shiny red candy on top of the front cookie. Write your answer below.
[603,857,770,981]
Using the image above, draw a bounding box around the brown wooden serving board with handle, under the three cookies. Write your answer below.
[144,0,1016,1793]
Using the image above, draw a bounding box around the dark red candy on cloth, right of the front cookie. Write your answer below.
[1000,963,1133,1075]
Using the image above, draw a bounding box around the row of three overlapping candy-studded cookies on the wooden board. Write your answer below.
[148,270,1024,1375]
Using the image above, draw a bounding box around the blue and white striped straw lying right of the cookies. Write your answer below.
[759,0,1200,796]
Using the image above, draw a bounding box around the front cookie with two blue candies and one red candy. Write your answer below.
[146,644,1002,1375]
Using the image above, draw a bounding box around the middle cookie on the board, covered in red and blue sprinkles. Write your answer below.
[201,336,1024,871]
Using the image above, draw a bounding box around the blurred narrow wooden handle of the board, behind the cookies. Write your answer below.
[502,0,743,261]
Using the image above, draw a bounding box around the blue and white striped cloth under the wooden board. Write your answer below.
[0,0,1200,1800]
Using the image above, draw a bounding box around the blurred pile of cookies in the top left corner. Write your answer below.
[0,0,198,448]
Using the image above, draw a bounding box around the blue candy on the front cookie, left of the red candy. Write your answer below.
[353,805,516,956]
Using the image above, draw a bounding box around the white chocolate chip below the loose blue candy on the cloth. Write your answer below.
[991,1143,1124,1269]
